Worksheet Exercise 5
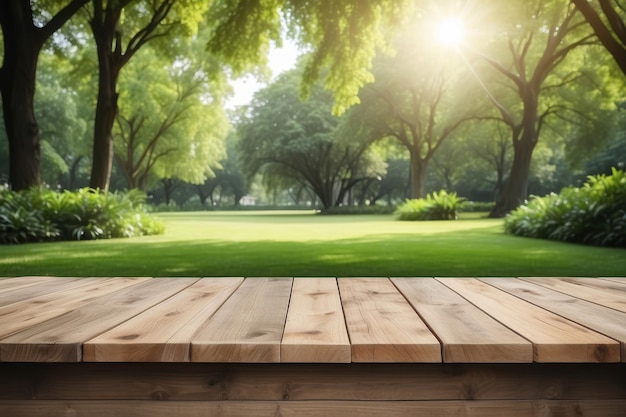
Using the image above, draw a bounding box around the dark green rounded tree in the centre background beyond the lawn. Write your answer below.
[238,71,382,208]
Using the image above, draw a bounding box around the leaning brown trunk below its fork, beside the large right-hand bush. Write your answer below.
[489,136,537,218]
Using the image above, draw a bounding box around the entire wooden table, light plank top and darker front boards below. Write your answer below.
[0,277,626,417]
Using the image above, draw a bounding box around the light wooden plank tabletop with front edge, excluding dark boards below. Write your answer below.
[0,277,626,363]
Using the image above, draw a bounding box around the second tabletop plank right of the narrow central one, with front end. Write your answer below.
[392,278,533,363]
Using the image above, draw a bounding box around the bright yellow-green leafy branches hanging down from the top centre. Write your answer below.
[208,0,414,114]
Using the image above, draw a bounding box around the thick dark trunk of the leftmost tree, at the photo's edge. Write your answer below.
[0,5,42,191]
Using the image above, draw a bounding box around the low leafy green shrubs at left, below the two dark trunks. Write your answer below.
[0,188,164,243]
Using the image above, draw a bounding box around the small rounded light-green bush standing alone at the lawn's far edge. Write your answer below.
[395,190,463,220]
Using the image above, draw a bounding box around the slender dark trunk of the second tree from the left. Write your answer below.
[89,19,121,192]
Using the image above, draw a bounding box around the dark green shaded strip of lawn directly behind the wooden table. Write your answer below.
[0,228,626,277]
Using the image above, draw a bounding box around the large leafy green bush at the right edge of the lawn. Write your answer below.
[504,169,626,247]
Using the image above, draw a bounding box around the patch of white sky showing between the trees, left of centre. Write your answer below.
[226,39,300,109]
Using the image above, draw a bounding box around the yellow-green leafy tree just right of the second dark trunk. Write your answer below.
[114,42,228,190]
